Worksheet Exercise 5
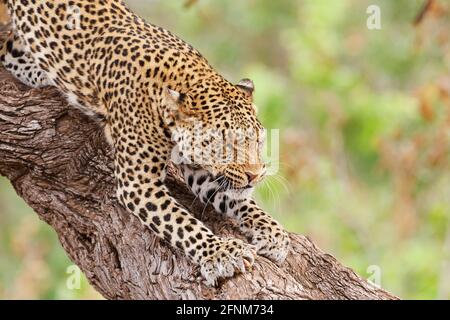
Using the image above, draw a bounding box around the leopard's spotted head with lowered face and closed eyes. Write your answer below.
[165,76,266,196]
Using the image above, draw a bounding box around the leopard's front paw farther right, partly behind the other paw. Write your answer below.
[251,225,291,265]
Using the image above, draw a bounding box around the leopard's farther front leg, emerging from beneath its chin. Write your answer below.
[183,166,290,264]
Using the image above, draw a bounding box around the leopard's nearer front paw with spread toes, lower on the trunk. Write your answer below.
[200,238,256,286]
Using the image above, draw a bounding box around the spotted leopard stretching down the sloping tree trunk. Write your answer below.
[0,0,290,286]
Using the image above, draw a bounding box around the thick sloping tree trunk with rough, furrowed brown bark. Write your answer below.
[0,26,396,299]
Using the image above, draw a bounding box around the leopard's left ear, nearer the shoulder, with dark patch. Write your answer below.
[162,88,193,125]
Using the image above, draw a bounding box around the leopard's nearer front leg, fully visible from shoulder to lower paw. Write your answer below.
[107,116,256,285]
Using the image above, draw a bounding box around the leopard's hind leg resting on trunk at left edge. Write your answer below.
[0,33,51,88]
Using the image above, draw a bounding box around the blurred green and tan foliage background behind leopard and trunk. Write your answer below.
[0,0,450,299]
